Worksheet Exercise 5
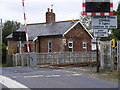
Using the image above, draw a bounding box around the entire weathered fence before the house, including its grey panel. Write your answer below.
[10,52,96,66]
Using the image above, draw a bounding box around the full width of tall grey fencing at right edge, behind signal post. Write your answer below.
[100,41,120,71]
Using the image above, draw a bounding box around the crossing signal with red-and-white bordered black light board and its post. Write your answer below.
[82,0,114,72]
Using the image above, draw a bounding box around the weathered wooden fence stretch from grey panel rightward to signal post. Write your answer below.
[37,52,96,65]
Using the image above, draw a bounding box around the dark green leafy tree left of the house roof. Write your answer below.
[2,21,20,45]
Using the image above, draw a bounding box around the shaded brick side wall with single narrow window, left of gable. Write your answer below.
[37,36,62,52]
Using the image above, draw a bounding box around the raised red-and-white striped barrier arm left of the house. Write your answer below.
[22,0,30,52]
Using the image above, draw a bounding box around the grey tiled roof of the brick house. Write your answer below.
[6,20,78,40]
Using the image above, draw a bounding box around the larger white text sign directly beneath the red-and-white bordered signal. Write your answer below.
[92,16,117,29]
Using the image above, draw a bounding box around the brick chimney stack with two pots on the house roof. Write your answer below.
[46,8,55,23]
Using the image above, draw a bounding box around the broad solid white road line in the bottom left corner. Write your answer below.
[0,75,31,90]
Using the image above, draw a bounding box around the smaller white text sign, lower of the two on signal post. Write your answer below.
[94,29,108,37]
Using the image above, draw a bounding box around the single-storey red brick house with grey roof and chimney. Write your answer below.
[7,8,93,54]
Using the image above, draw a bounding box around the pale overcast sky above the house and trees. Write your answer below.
[0,0,120,24]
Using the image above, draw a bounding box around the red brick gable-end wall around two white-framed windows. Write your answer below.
[65,23,91,52]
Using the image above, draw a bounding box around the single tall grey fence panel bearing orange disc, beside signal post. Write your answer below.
[100,41,113,70]
